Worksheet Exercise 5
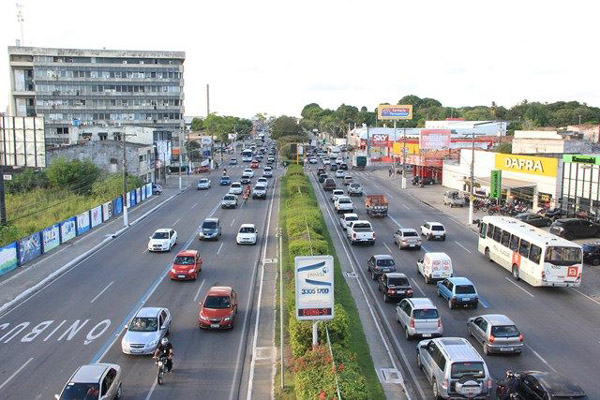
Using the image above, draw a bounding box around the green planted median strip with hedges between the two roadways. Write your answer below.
[276,165,385,400]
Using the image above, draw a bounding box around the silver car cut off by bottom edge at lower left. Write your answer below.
[54,363,122,400]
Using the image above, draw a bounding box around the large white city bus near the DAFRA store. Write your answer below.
[477,216,583,287]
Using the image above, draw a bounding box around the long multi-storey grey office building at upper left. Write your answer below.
[8,46,185,145]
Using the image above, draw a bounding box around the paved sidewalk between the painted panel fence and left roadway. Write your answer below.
[0,176,191,314]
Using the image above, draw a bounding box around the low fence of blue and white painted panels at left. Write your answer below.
[0,183,152,276]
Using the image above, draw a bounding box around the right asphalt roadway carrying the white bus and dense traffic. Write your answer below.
[313,163,600,399]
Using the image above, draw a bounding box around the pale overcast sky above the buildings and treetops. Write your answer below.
[0,0,600,118]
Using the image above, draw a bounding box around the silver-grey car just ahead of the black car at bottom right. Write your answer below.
[467,314,523,355]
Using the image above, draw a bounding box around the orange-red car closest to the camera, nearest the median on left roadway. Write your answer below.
[198,286,237,329]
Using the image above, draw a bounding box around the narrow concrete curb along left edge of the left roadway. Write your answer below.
[0,188,186,316]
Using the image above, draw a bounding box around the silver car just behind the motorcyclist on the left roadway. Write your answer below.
[121,307,171,354]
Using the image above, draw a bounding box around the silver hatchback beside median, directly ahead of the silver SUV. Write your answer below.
[396,297,444,340]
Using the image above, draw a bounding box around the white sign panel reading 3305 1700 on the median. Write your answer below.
[294,256,334,320]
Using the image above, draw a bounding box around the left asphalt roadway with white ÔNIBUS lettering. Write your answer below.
[0,160,276,400]
